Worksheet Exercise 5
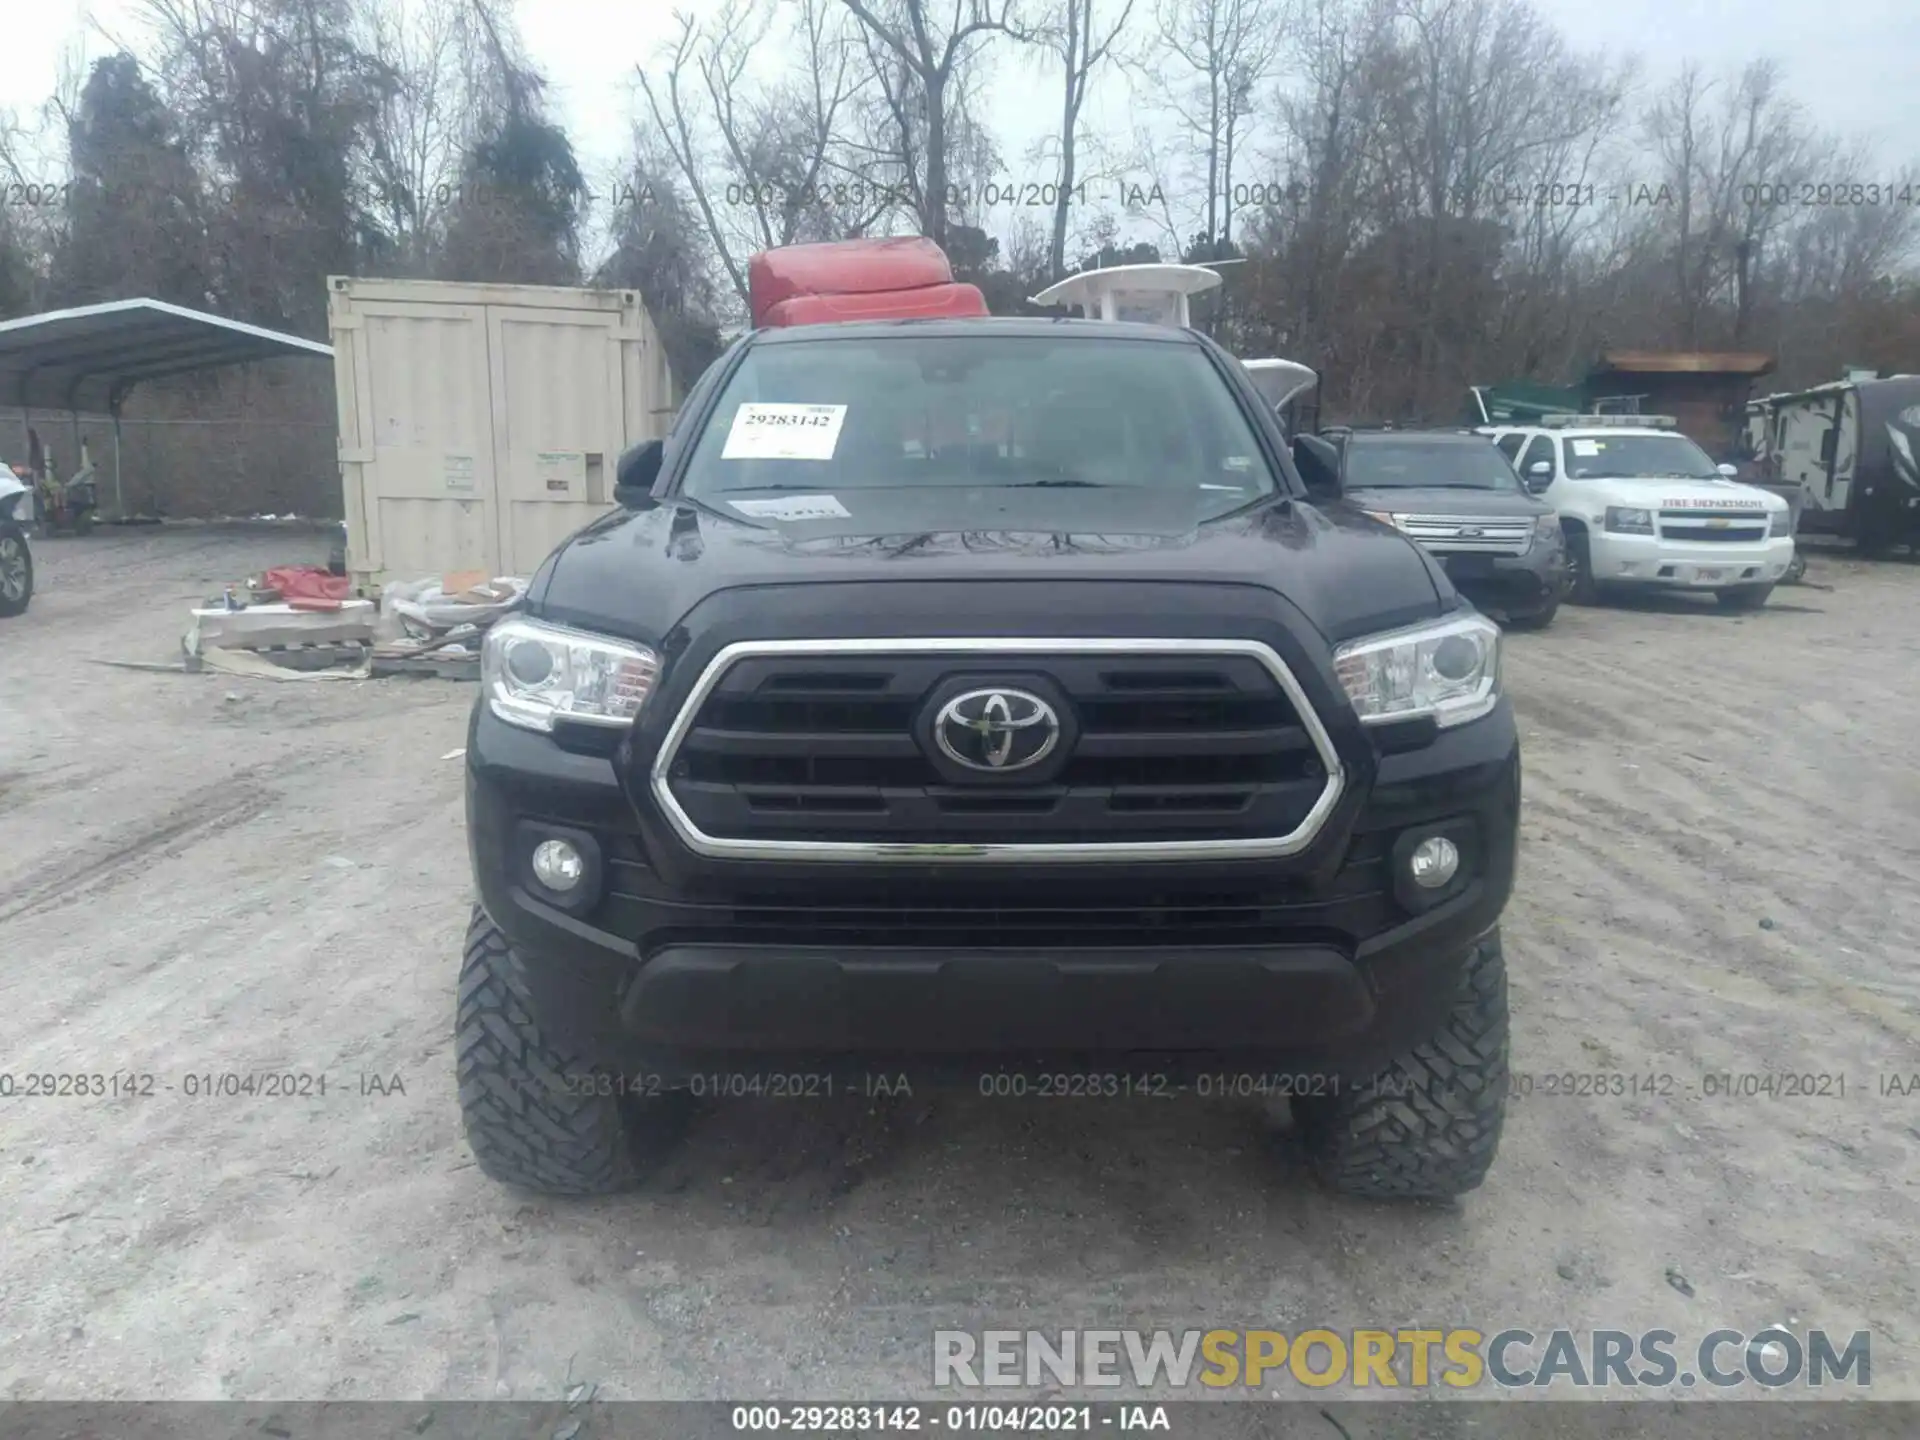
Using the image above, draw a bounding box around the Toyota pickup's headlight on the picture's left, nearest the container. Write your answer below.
[480,616,660,733]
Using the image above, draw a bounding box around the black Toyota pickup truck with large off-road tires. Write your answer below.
[457,319,1521,1196]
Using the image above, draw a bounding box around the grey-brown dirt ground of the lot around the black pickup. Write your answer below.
[0,528,1920,1400]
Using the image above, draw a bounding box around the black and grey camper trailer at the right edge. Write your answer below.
[1745,374,1920,553]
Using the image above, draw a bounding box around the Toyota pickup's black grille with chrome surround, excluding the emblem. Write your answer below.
[651,639,1344,862]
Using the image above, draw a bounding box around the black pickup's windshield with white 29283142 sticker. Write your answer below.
[682,334,1277,518]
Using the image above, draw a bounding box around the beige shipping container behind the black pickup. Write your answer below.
[326,275,674,591]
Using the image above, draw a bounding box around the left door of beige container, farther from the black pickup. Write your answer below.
[334,301,499,584]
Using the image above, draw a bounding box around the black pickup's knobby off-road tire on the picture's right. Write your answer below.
[1294,929,1507,1200]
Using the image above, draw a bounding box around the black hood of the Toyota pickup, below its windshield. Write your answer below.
[528,488,1452,643]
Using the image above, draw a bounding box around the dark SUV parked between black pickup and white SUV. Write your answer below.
[1334,430,1569,630]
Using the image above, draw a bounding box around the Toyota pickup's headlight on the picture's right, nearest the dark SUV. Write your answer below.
[1332,611,1500,730]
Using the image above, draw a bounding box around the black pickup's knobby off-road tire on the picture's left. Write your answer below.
[453,906,680,1196]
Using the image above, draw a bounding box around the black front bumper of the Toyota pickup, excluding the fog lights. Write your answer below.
[467,701,1521,1075]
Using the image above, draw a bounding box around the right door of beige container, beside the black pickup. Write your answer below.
[486,305,628,576]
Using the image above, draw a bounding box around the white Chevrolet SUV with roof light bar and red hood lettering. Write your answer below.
[1480,415,1793,611]
